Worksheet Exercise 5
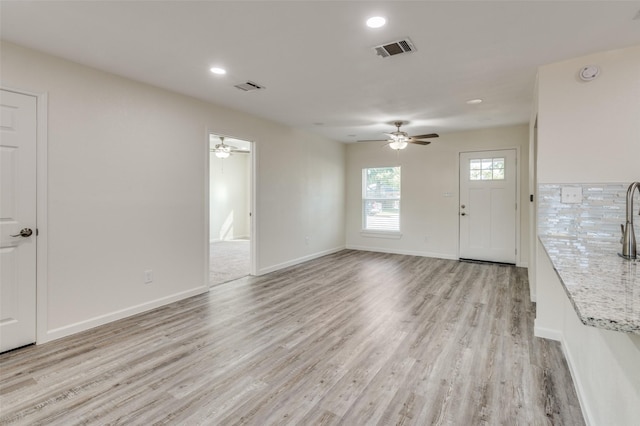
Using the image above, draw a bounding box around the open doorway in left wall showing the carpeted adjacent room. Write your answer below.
[209,134,253,286]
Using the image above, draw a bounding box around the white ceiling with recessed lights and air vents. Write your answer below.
[0,0,640,142]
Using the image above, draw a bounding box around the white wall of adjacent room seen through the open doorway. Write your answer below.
[209,151,251,242]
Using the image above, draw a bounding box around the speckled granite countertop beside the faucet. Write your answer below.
[539,235,640,334]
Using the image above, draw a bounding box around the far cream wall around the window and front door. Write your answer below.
[347,125,529,266]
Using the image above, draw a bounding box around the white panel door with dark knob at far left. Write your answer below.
[0,90,36,352]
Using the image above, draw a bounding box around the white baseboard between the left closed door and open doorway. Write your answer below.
[42,286,209,344]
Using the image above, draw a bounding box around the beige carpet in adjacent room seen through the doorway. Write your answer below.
[209,240,249,285]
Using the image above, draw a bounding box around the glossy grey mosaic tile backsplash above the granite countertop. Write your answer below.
[538,182,640,243]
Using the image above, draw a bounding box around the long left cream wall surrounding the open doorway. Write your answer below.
[0,42,345,342]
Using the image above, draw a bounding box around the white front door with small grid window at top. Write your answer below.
[459,149,518,264]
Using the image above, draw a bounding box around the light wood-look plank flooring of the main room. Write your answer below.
[0,250,584,426]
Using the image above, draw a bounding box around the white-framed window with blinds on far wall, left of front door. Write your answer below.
[362,167,400,232]
